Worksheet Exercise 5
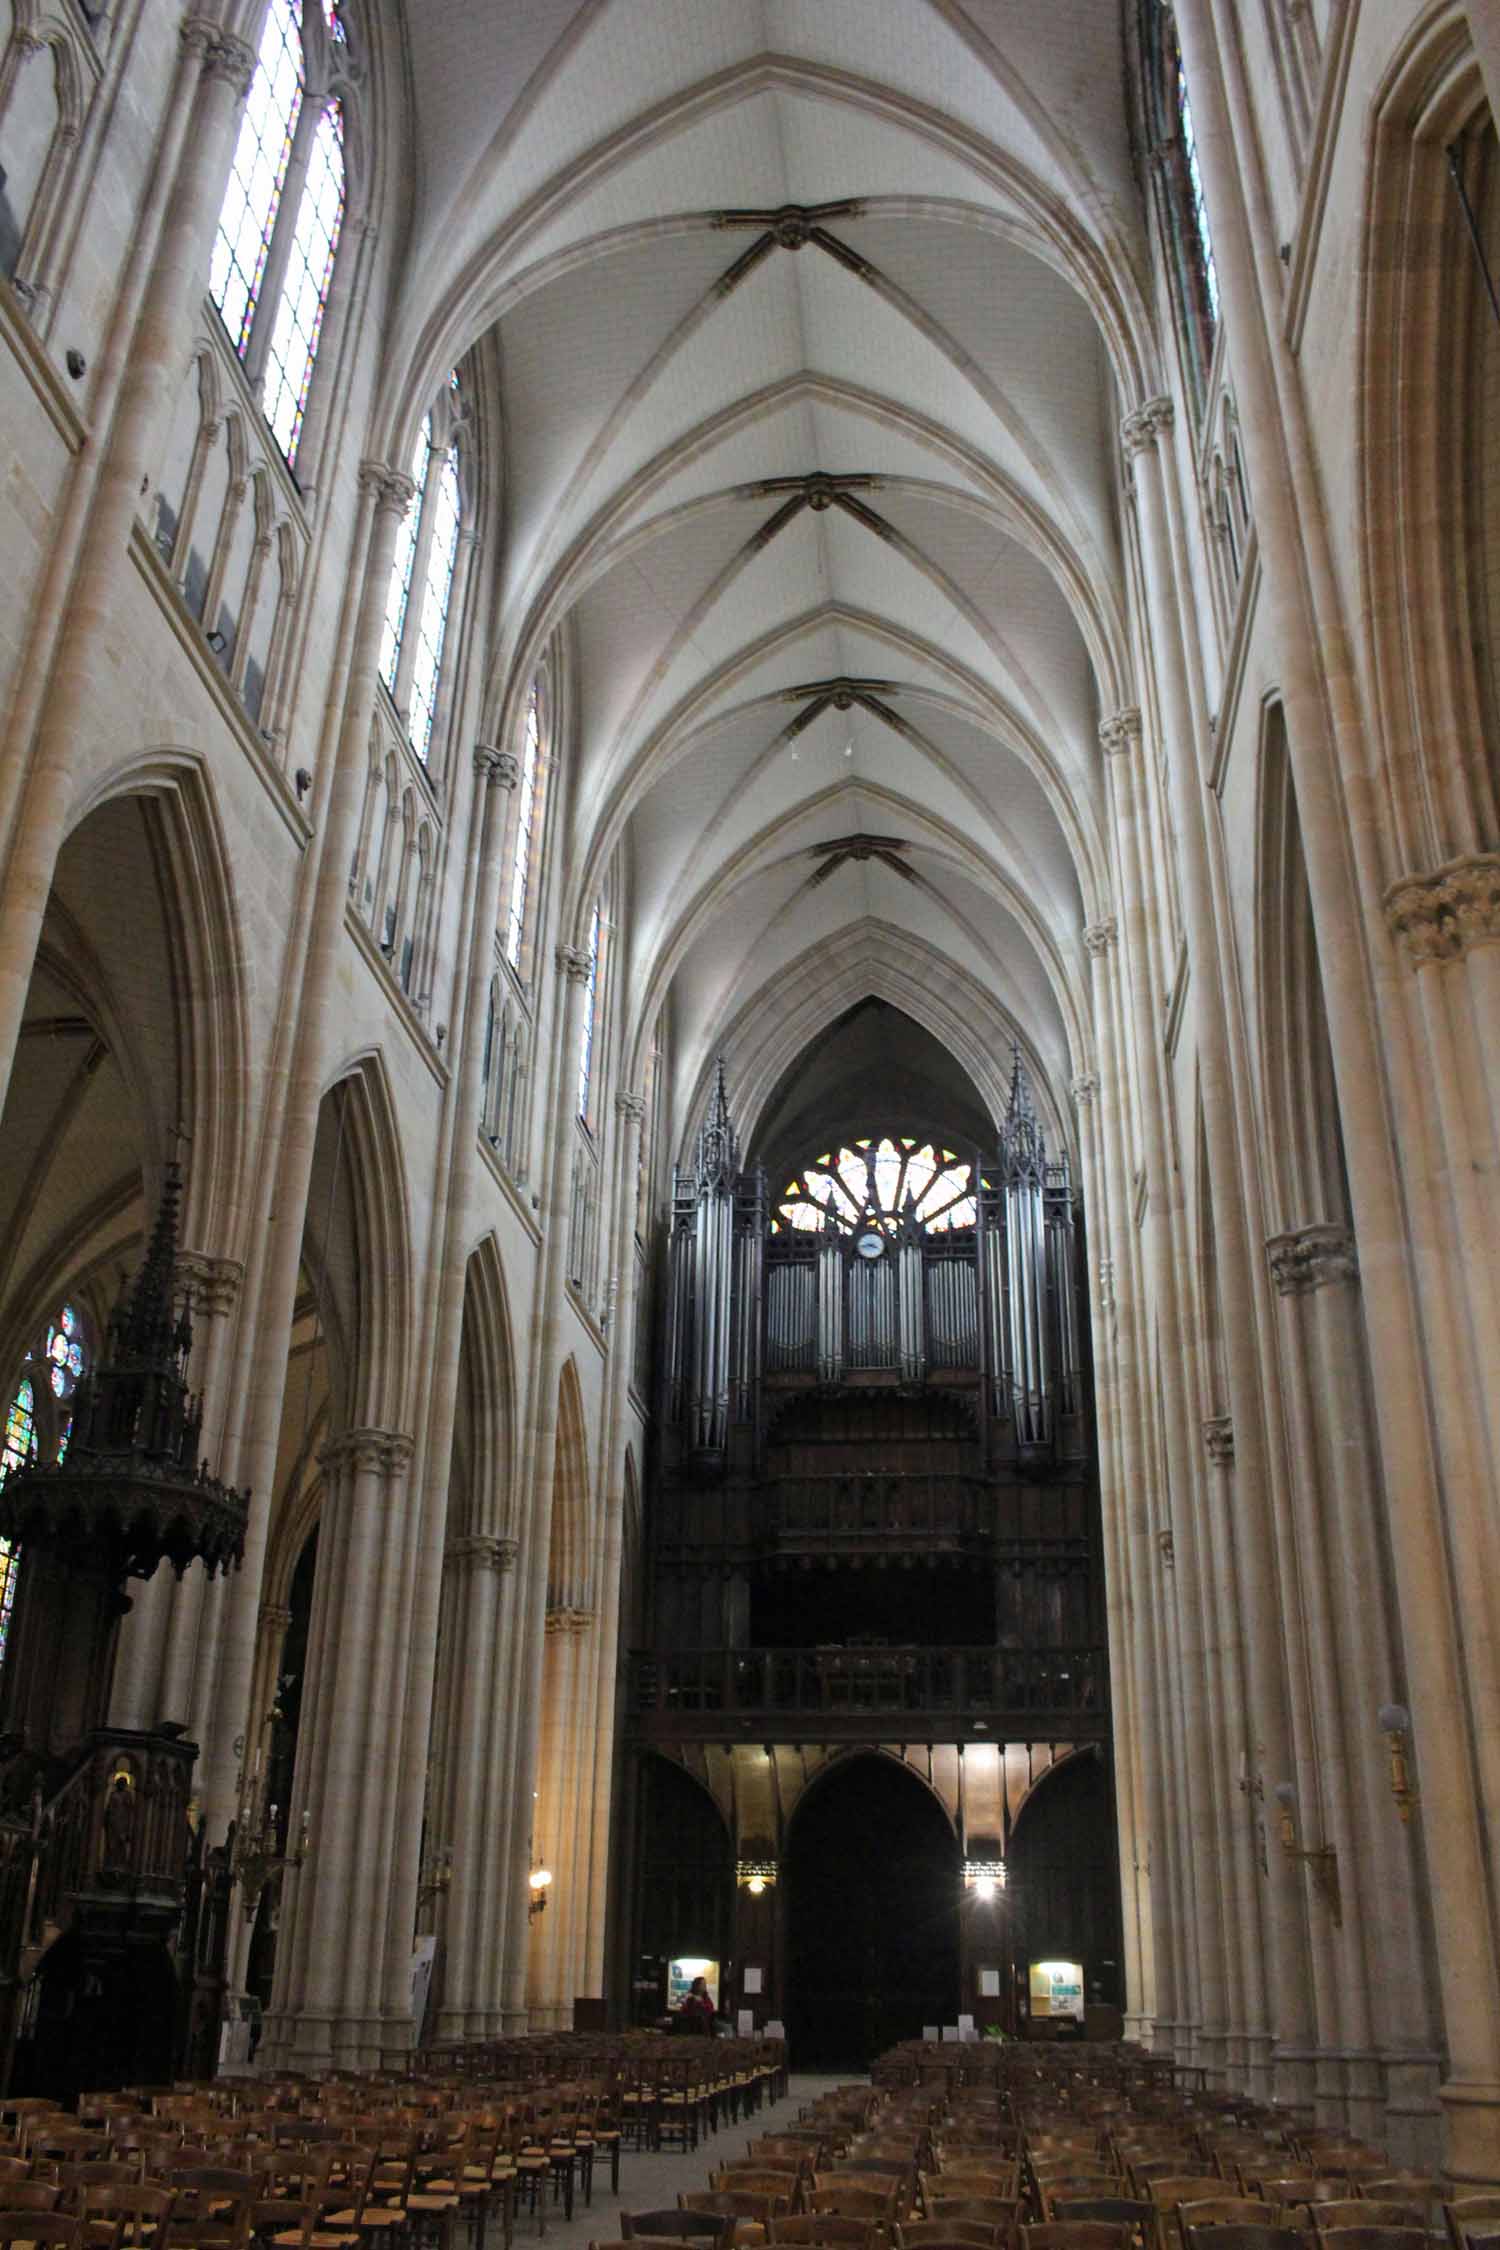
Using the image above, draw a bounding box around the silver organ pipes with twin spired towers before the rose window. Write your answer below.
[666,1055,1084,1474]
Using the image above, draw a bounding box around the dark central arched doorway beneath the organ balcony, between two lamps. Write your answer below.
[785,1753,960,2070]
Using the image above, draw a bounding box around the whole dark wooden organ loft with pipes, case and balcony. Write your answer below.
[625,1055,1120,2009]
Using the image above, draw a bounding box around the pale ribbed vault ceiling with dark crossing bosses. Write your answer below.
[391,0,1149,1132]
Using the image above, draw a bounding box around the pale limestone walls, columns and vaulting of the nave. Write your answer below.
[0,0,1500,2180]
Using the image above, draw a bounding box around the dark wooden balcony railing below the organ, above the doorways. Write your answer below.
[630,1647,1109,1742]
